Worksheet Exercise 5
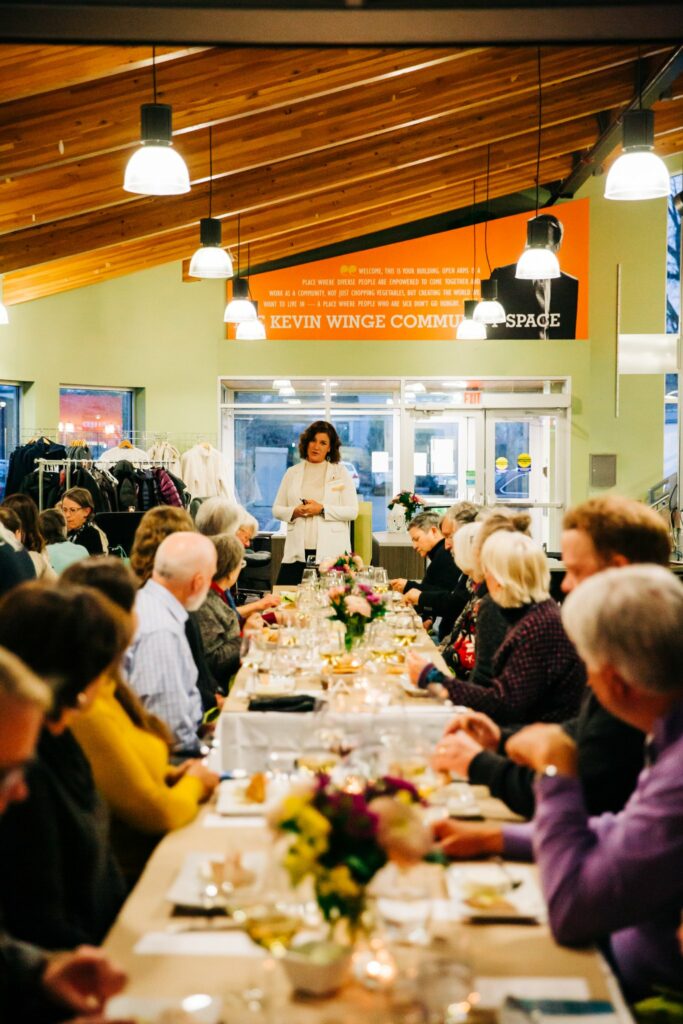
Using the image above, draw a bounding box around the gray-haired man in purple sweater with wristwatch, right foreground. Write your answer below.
[436,565,683,998]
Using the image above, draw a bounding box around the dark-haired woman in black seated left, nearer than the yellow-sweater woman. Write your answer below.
[0,582,130,949]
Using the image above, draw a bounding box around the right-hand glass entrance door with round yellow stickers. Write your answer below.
[484,410,567,551]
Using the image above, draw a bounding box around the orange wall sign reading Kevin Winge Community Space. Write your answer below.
[248,200,589,341]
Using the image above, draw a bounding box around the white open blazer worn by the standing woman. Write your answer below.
[272,461,358,562]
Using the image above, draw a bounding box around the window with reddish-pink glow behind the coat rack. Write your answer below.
[59,387,133,457]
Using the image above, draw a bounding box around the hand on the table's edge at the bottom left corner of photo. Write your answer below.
[41,946,128,1017]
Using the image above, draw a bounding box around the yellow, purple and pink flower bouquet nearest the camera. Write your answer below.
[270,774,432,933]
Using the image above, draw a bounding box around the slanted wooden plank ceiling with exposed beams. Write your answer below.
[0,43,683,305]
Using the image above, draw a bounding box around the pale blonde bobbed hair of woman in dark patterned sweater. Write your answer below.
[481,525,550,608]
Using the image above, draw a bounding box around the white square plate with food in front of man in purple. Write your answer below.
[445,862,547,924]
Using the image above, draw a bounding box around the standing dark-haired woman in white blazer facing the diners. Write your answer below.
[272,420,358,586]
